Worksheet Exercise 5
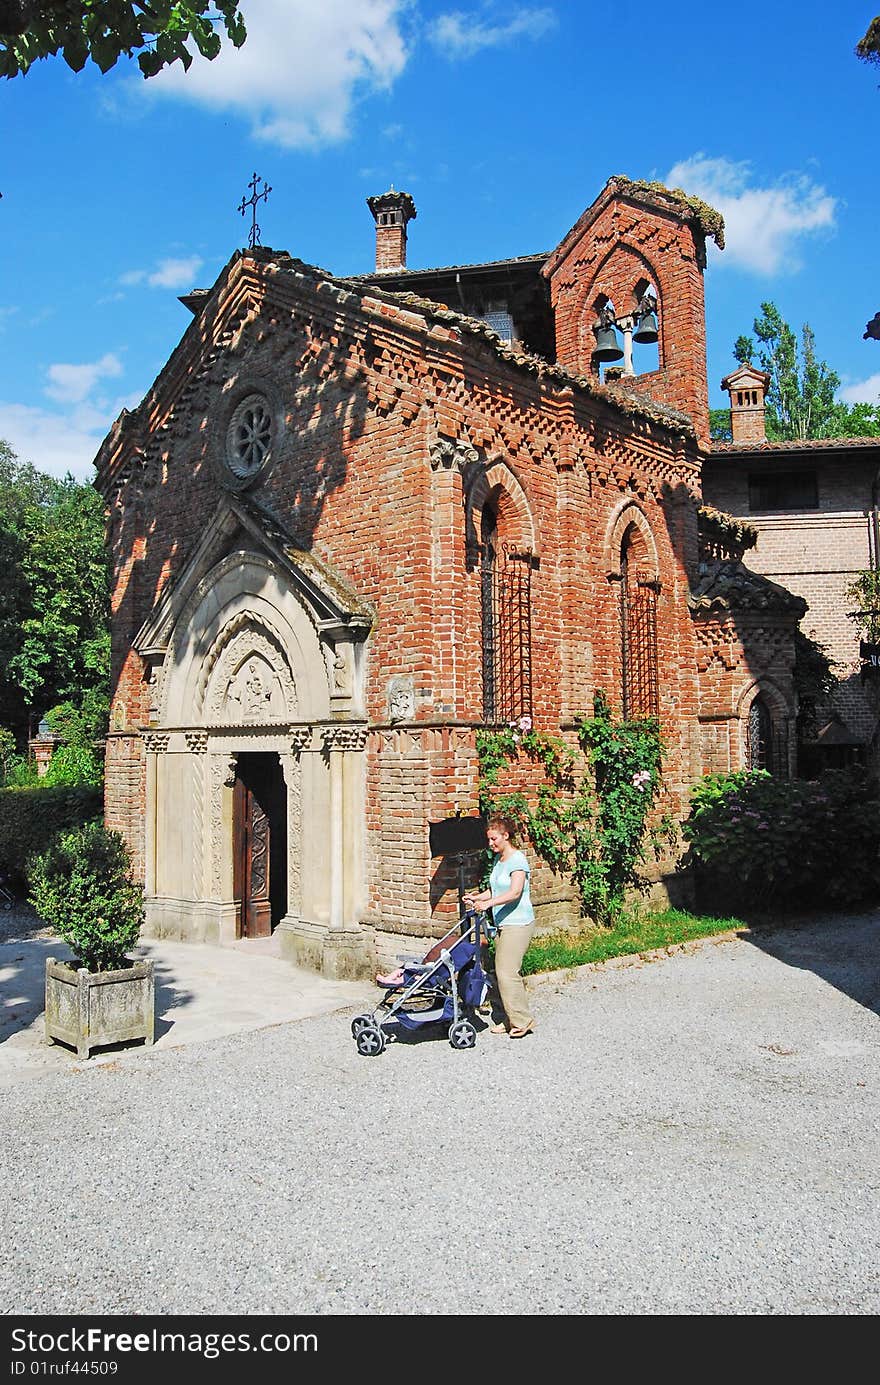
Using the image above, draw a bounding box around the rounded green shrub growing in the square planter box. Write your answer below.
[29,823,144,971]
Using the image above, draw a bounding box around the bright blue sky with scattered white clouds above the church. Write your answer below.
[0,0,880,476]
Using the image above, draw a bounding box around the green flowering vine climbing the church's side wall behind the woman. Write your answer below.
[477,693,662,925]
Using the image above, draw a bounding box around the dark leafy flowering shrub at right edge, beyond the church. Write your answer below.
[682,769,880,909]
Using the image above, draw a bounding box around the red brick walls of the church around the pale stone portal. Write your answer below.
[101,259,787,933]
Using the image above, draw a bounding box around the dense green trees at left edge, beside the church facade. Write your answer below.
[0,443,109,737]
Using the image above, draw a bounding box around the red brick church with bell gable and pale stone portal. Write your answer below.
[97,177,805,976]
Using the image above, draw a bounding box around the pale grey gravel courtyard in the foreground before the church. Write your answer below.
[0,914,880,1314]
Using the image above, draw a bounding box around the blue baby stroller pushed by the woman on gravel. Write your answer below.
[352,910,493,1058]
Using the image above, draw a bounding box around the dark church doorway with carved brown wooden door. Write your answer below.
[233,755,287,938]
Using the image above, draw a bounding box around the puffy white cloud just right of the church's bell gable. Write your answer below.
[664,154,837,274]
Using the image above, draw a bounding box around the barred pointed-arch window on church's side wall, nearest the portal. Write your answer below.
[479,504,532,724]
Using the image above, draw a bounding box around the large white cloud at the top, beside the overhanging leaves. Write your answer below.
[150,0,410,148]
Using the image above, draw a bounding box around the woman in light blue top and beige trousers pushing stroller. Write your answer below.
[464,817,535,1039]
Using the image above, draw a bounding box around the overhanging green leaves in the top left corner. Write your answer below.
[0,0,247,78]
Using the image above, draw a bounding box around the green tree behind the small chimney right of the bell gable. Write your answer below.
[733,303,880,442]
